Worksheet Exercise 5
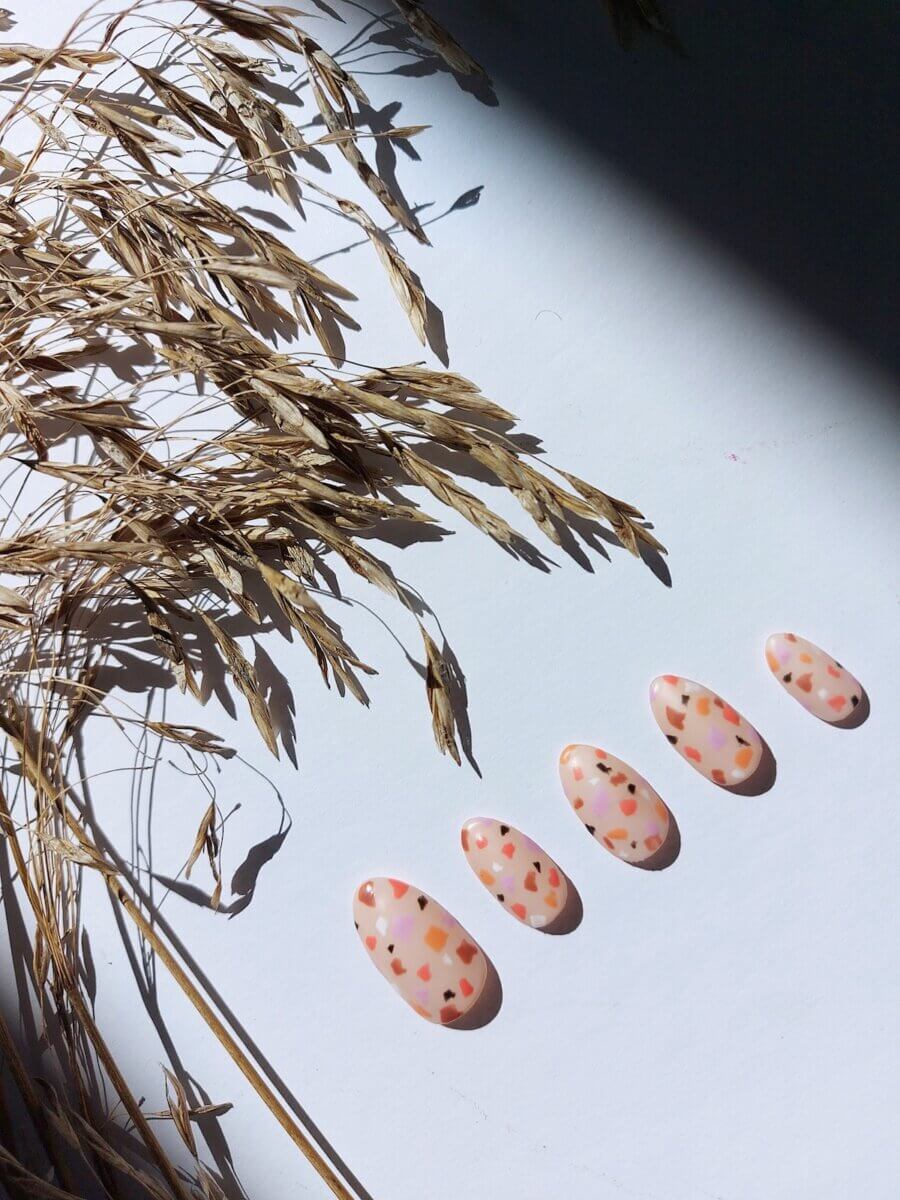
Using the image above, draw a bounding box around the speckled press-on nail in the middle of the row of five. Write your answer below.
[559,745,671,863]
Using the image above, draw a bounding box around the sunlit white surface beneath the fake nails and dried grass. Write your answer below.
[7,4,900,1200]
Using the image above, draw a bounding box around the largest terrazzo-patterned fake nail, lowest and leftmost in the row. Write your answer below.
[353,878,487,1025]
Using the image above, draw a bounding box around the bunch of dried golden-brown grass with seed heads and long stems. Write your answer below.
[0,0,662,1200]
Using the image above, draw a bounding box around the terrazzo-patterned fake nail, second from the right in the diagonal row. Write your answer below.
[650,676,763,787]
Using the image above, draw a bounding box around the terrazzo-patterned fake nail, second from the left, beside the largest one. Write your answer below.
[461,817,569,929]
